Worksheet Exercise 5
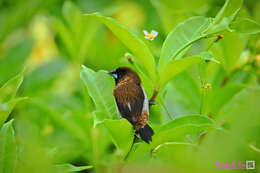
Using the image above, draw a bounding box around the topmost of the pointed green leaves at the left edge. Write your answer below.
[0,68,24,102]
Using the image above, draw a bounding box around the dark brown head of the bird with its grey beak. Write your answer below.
[109,67,141,84]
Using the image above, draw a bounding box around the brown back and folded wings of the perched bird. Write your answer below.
[114,82,145,125]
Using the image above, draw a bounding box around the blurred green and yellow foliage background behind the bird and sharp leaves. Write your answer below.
[0,0,260,173]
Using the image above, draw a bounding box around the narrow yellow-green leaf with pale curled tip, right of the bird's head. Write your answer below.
[160,52,218,89]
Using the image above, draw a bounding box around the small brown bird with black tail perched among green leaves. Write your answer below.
[109,67,154,144]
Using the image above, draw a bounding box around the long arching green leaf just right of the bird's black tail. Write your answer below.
[130,115,217,160]
